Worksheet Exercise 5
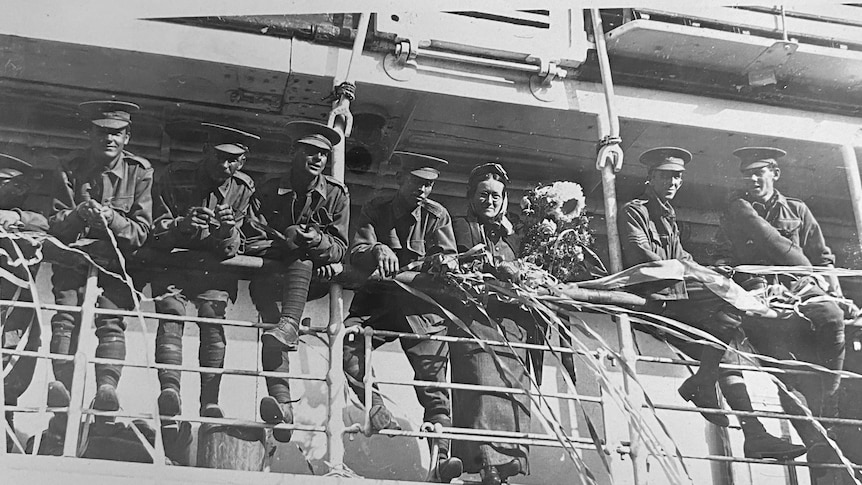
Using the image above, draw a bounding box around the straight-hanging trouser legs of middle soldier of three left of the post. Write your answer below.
[156,296,227,409]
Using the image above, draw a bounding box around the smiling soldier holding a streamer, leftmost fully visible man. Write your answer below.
[48,101,153,411]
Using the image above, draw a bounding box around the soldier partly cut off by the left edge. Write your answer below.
[0,153,48,448]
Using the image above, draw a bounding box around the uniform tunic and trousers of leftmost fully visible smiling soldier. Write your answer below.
[48,152,153,389]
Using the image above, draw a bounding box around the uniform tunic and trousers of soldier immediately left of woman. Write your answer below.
[344,195,456,434]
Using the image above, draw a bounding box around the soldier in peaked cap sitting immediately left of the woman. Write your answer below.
[344,152,463,483]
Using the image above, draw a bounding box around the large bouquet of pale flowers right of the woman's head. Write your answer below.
[517,182,604,282]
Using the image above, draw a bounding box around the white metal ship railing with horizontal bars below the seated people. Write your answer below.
[0,253,862,484]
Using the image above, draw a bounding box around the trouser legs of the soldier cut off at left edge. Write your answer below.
[0,265,42,406]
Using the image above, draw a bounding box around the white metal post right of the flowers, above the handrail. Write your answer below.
[590,8,623,273]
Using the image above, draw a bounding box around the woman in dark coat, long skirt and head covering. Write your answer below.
[450,163,535,485]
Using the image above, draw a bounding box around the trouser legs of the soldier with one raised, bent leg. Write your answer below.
[249,253,313,404]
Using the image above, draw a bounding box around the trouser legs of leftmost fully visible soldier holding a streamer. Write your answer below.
[51,265,134,389]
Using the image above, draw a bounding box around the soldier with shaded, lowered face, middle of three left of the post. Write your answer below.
[150,123,260,418]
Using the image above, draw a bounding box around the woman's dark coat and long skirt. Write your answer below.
[450,216,535,473]
